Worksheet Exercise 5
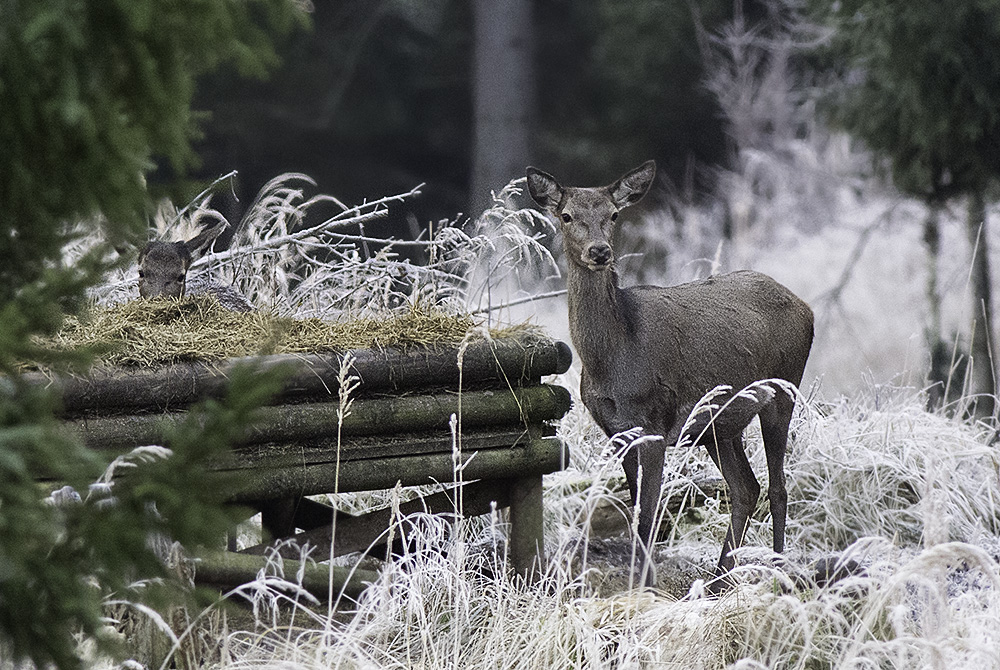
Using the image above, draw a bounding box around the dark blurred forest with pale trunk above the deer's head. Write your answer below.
[188,0,752,230]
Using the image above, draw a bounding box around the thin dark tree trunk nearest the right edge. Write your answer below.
[967,191,996,419]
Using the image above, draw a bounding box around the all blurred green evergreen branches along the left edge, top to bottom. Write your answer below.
[0,0,305,668]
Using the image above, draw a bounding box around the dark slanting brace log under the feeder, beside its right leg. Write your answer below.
[241,480,512,561]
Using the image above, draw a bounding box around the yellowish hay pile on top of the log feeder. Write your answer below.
[33,295,523,368]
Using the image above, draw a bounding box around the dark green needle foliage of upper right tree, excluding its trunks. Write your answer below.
[814,0,1000,201]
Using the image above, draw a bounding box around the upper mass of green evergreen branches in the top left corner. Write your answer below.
[0,0,300,294]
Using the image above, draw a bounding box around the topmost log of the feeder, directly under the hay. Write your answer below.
[23,335,572,414]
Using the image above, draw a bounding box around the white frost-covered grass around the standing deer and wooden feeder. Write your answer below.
[76,163,1000,670]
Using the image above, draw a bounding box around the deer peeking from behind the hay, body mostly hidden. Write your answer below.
[139,221,253,312]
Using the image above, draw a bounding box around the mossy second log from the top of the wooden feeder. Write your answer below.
[65,384,571,451]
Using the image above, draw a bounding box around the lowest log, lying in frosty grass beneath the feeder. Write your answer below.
[195,551,378,600]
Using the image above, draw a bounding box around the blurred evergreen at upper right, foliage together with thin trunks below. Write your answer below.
[813,0,1000,419]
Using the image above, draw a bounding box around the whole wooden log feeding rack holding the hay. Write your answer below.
[27,333,571,595]
